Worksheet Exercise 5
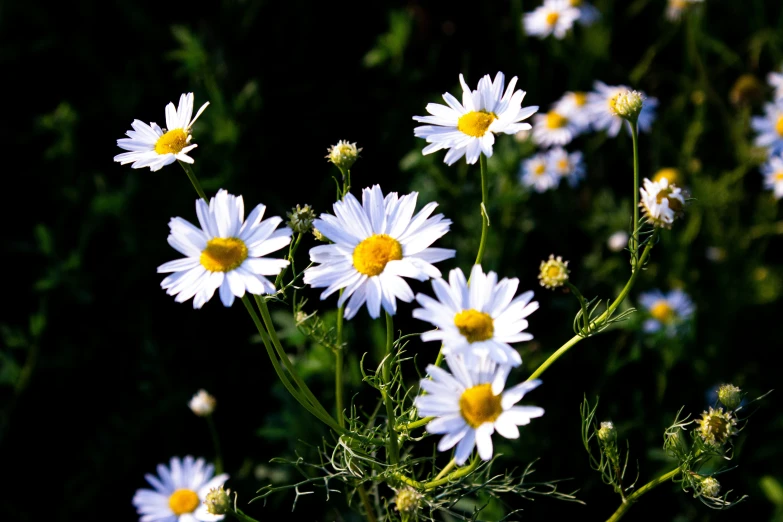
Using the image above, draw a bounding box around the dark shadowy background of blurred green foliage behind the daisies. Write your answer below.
[0,0,783,521]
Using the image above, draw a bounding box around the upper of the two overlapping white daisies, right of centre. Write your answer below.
[413,265,538,366]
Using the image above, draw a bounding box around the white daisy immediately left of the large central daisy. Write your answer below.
[158,189,291,308]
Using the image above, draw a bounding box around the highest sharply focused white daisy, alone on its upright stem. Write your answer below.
[413,72,538,165]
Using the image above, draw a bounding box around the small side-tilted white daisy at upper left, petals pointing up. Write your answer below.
[114,92,209,172]
